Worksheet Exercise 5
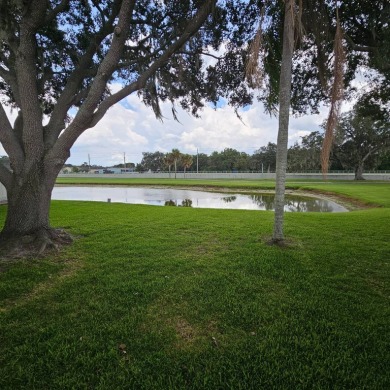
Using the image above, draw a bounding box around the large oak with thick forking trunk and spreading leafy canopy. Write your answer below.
[0,0,257,254]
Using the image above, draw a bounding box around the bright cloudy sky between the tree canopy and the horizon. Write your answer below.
[0,82,354,166]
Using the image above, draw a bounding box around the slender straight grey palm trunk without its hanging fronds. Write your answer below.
[272,0,294,243]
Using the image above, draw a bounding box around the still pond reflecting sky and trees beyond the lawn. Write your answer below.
[52,186,348,213]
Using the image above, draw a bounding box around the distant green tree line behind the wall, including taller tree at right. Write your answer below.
[136,105,390,180]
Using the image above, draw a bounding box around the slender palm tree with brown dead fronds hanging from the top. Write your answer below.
[246,0,345,244]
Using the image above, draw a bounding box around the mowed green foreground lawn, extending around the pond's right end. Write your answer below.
[0,182,390,389]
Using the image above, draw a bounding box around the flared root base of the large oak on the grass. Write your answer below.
[0,228,73,259]
